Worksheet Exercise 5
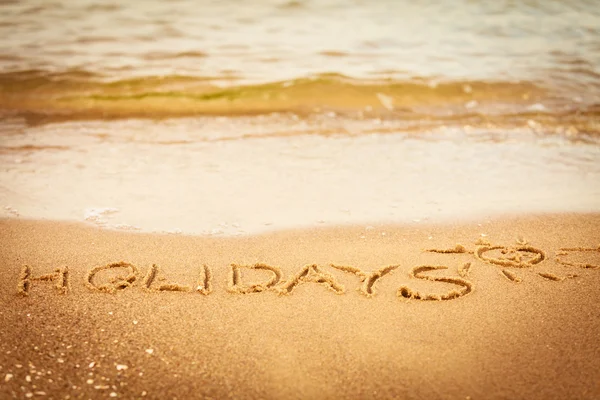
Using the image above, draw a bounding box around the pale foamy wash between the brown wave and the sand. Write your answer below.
[0,116,600,235]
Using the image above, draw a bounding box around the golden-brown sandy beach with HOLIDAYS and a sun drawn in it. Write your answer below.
[0,214,600,399]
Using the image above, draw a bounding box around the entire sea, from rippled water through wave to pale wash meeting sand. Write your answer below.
[0,0,600,235]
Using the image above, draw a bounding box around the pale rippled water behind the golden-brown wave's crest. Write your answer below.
[0,0,600,87]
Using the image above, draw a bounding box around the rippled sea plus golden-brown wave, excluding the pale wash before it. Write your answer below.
[0,0,600,122]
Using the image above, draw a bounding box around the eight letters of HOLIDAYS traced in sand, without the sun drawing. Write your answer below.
[17,261,473,300]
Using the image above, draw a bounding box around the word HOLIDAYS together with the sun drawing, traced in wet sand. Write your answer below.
[17,239,600,300]
